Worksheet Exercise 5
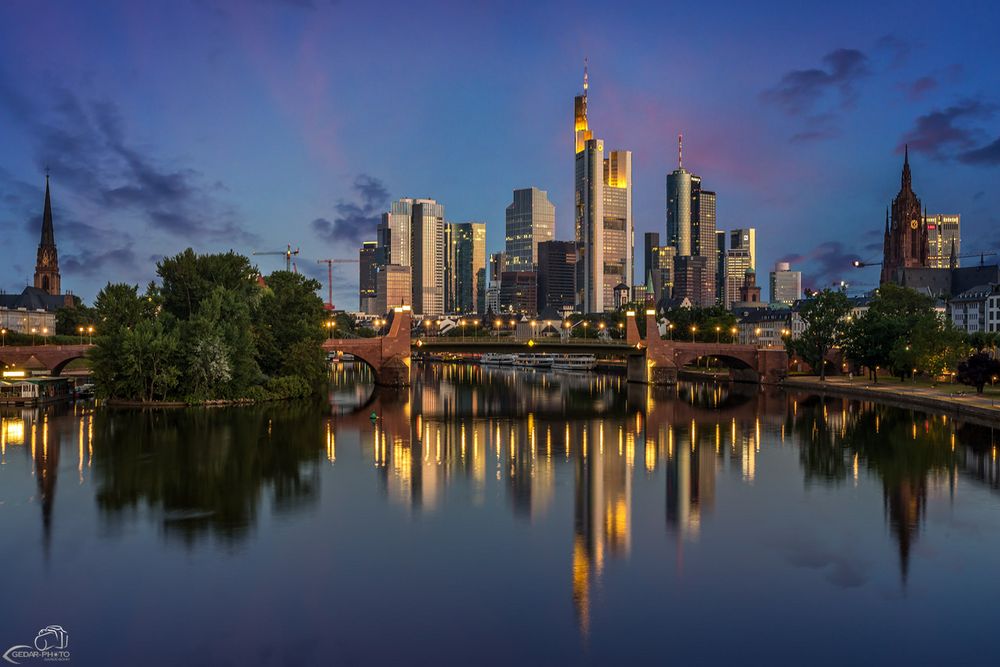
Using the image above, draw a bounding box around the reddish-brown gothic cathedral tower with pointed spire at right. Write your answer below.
[879,148,930,284]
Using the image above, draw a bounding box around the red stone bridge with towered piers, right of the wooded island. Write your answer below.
[323,306,788,386]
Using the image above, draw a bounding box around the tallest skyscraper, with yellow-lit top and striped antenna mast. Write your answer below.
[573,68,634,313]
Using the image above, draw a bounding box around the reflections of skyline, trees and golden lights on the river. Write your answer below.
[11,366,1000,633]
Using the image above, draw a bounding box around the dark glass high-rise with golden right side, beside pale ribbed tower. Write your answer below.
[444,222,486,313]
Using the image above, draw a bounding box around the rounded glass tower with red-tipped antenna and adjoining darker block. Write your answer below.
[667,135,718,306]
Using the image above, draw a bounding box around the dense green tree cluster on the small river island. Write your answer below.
[89,248,327,403]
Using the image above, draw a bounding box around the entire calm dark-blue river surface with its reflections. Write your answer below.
[0,366,1000,665]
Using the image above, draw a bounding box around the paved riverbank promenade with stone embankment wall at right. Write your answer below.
[781,376,1000,423]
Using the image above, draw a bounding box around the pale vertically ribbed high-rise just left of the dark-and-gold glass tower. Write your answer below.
[410,199,445,315]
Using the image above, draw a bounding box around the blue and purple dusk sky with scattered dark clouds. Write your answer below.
[0,0,1000,309]
